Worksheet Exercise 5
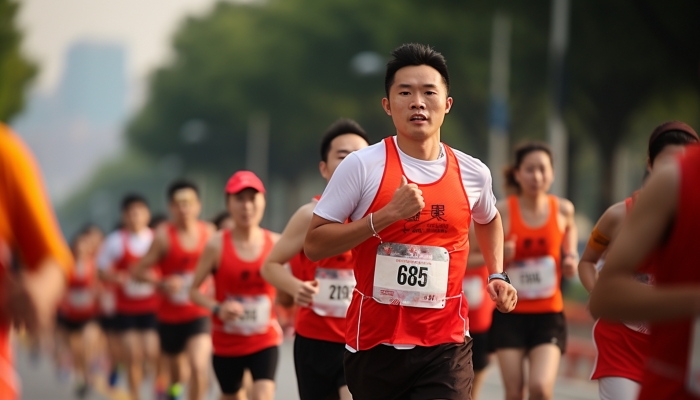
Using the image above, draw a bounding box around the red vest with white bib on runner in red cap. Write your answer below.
[212,230,282,357]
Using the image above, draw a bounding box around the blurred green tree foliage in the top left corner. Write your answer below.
[0,0,37,122]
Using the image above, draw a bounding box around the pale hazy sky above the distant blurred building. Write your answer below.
[19,0,216,91]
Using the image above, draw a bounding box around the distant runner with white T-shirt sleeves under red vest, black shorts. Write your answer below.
[97,194,159,400]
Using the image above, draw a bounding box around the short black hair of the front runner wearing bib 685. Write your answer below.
[384,43,450,97]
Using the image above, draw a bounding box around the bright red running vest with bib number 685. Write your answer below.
[345,138,472,350]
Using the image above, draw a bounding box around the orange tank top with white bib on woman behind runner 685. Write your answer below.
[506,195,564,313]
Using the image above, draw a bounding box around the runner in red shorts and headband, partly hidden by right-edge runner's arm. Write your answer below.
[578,122,698,400]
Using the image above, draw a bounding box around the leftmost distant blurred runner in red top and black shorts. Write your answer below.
[57,230,99,399]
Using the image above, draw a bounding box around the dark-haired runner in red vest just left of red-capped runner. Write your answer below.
[132,181,214,400]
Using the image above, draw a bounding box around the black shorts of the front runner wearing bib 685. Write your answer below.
[345,337,474,400]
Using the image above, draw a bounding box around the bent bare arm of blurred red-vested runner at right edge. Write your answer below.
[590,163,700,321]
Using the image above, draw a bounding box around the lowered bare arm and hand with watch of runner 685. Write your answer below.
[474,212,518,312]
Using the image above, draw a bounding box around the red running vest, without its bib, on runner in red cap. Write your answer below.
[212,230,282,357]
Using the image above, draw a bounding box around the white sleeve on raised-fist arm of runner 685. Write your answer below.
[314,153,365,223]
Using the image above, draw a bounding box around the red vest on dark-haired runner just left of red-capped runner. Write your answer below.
[158,222,210,324]
